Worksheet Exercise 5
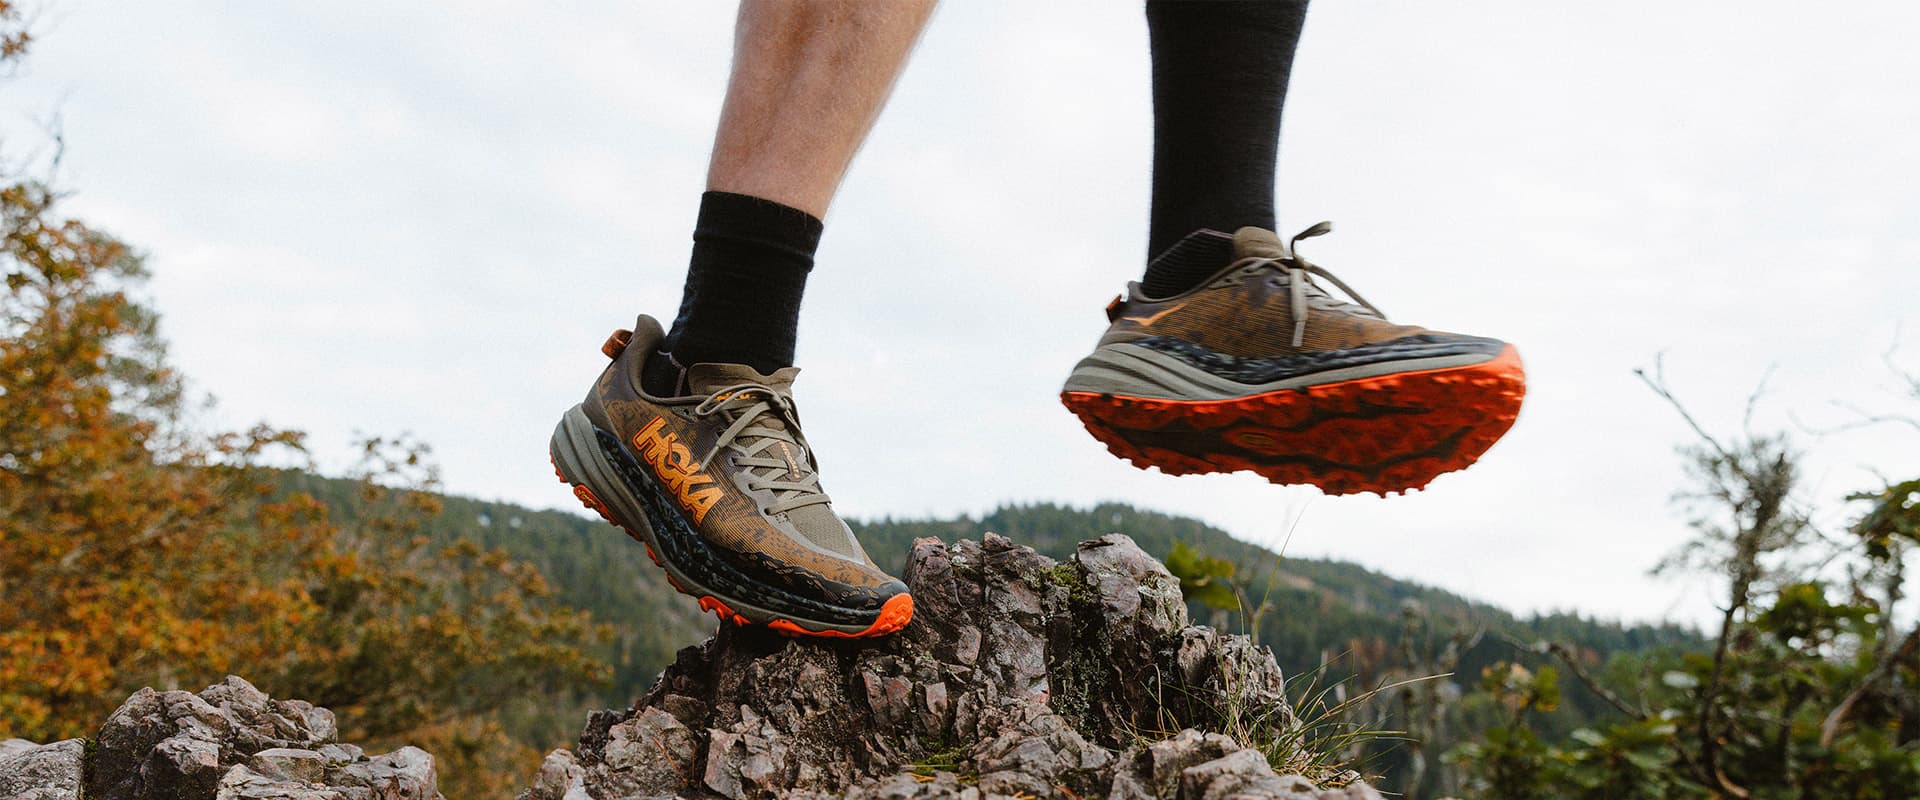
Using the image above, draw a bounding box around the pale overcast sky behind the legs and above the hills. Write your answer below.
[0,0,1920,622]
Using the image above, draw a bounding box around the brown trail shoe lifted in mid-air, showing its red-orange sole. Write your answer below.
[1060,223,1526,495]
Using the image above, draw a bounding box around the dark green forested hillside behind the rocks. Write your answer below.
[284,472,1705,790]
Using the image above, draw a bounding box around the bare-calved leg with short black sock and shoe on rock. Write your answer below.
[549,0,933,637]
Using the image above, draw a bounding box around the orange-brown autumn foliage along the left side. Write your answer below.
[0,12,607,790]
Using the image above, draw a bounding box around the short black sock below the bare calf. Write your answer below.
[639,192,822,397]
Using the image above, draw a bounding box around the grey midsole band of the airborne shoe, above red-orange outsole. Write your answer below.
[1062,340,1503,401]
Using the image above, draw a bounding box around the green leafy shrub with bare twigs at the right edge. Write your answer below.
[1453,364,1920,798]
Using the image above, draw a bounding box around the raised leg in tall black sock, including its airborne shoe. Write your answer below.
[1062,0,1526,495]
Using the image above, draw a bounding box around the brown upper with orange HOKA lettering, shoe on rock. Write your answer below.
[582,317,906,608]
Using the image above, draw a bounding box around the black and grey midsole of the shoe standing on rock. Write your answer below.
[549,405,879,633]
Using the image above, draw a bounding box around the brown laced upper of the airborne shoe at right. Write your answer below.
[1100,223,1465,359]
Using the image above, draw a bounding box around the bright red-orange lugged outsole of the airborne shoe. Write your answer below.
[1060,345,1526,497]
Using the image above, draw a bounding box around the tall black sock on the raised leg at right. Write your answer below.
[1140,0,1308,297]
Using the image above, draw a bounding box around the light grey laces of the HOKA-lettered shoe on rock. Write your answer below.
[693,384,831,514]
